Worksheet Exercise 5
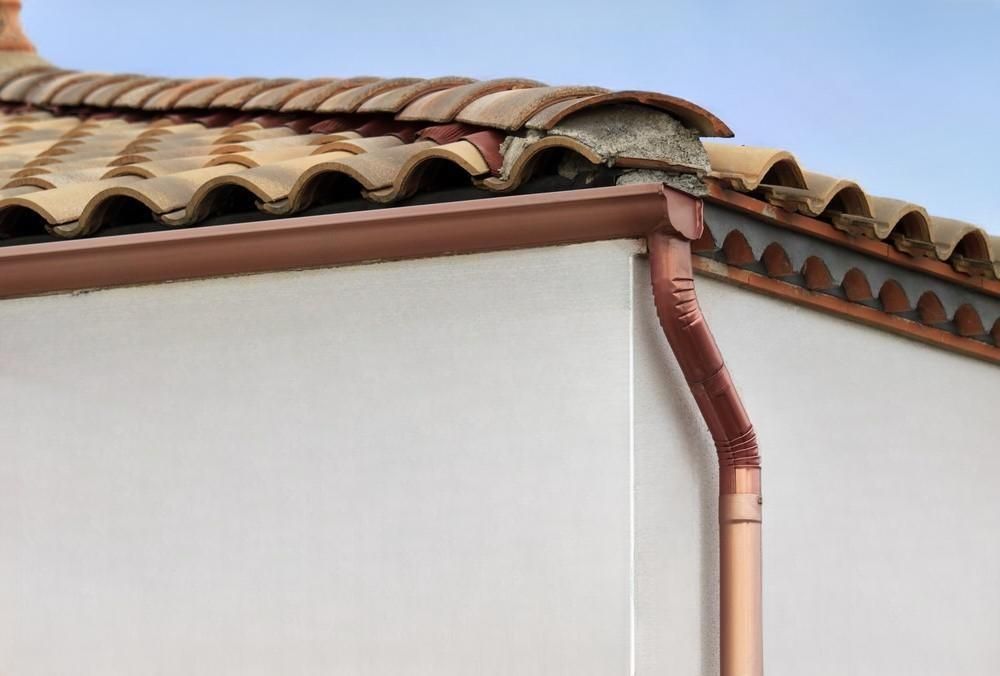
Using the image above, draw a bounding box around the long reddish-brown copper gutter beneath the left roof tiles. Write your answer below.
[0,184,665,298]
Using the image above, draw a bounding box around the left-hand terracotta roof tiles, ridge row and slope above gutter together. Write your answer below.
[0,68,748,250]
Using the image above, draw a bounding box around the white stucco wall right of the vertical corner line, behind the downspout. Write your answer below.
[635,261,1000,676]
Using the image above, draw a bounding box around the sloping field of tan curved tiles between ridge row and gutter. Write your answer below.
[0,112,620,237]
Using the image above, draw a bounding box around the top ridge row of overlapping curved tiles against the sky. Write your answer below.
[0,66,732,136]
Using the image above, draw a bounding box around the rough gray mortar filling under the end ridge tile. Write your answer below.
[500,104,709,192]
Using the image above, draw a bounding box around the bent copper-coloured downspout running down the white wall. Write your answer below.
[647,188,764,676]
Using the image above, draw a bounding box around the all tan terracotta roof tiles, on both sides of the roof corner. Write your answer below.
[0,66,1000,292]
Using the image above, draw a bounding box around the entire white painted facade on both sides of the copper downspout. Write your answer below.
[0,242,1000,676]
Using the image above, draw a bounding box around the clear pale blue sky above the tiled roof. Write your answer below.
[23,0,1000,234]
